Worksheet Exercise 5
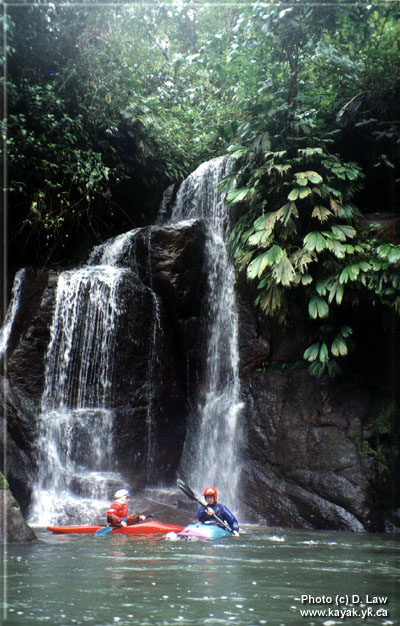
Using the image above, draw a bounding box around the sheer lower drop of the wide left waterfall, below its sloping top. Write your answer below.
[31,266,127,525]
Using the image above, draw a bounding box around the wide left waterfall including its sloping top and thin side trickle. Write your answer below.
[30,224,166,526]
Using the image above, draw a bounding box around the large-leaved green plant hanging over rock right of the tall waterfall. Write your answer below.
[227,127,400,376]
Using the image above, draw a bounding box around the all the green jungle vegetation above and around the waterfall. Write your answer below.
[2,0,400,375]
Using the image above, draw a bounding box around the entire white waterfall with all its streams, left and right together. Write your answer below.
[7,158,241,526]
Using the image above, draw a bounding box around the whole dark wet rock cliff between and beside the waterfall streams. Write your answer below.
[0,220,398,530]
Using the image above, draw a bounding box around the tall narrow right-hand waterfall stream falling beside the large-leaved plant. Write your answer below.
[167,157,241,507]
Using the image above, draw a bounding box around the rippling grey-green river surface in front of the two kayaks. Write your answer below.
[2,526,400,626]
